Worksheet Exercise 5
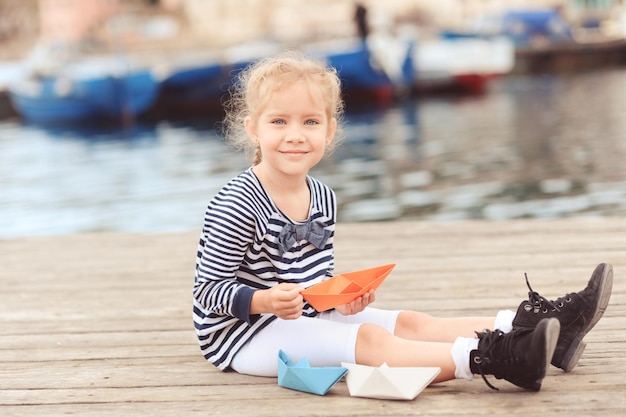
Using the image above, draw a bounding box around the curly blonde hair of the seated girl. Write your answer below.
[223,51,344,165]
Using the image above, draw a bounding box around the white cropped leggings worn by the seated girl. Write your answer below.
[230,307,400,377]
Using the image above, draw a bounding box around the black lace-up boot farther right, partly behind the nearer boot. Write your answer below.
[513,264,613,372]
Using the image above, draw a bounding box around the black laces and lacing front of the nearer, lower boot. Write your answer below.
[474,330,518,391]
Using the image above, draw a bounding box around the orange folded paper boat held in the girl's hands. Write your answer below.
[302,264,396,311]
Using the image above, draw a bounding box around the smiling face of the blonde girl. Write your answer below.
[245,81,337,176]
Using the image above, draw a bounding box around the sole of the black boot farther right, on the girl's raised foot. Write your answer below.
[552,264,613,372]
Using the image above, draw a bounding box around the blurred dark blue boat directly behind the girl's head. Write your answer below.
[150,39,415,119]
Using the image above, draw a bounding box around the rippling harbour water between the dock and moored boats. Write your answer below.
[0,68,626,238]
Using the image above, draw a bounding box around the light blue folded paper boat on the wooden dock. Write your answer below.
[278,350,348,395]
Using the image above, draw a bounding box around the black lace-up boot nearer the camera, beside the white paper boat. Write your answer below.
[470,319,560,391]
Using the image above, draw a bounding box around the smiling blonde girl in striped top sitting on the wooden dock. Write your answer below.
[193,53,613,390]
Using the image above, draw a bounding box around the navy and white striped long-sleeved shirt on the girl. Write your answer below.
[193,169,337,370]
